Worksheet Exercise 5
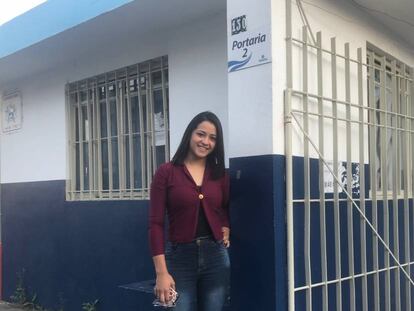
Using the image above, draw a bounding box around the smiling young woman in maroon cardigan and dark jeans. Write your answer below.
[149,111,230,311]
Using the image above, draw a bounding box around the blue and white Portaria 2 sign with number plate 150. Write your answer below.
[227,14,272,72]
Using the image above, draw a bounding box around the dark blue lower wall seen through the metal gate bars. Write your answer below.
[293,157,414,310]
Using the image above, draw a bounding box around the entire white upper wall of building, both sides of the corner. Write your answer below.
[0,0,414,183]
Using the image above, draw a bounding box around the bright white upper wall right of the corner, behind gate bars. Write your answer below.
[272,0,414,161]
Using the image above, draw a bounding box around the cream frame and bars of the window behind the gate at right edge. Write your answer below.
[367,45,414,198]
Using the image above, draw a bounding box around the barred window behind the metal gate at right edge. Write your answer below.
[368,52,412,195]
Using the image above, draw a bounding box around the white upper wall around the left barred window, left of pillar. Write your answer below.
[0,12,228,183]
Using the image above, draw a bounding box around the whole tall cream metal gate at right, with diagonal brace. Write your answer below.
[285,1,414,311]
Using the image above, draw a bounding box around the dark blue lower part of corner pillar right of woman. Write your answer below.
[230,155,287,311]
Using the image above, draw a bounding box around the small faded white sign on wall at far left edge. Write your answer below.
[1,92,23,133]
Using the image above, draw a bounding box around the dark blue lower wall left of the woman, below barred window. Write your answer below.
[2,181,153,311]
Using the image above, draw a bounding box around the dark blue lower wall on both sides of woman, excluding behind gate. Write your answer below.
[2,156,287,311]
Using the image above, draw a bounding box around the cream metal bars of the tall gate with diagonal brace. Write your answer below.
[285,20,414,310]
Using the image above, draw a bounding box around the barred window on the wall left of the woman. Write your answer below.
[66,56,169,200]
